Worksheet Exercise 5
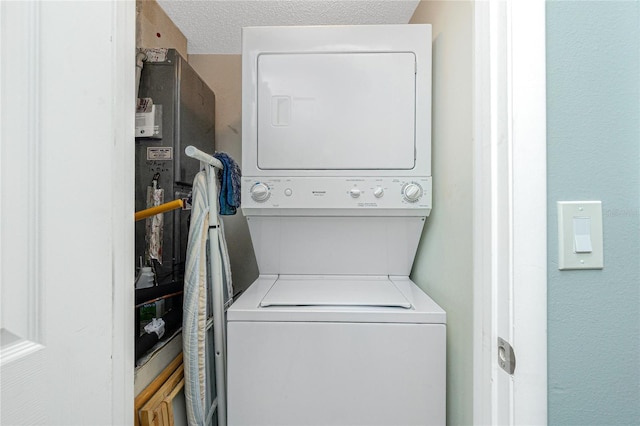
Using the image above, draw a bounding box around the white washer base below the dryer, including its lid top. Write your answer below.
[228,275,446,426]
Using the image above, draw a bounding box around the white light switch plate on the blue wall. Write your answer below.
[558,201,604,270]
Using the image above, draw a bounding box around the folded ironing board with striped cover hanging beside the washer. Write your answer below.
[183,146,233,426]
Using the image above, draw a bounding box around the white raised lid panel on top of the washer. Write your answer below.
[260,276,411,309]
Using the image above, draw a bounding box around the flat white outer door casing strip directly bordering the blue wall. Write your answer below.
[510,0,547,425]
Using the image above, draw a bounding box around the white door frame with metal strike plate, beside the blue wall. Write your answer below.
[473,0,547,425]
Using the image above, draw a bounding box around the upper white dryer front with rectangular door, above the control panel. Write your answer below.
[242,25,431,180]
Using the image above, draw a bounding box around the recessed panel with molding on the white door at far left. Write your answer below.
[0,2,45,365]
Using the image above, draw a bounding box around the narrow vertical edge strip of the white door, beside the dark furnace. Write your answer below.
[110,0,136,424]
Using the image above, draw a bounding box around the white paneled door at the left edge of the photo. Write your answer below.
[0,0,135,425]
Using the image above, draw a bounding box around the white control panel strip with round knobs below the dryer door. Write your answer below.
[242,177,431,209]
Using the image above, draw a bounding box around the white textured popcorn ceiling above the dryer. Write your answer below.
[158,0,419,54]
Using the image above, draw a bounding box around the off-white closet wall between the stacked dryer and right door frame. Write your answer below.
[410,0,474,425]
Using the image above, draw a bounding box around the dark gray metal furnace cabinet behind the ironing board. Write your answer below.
[135,49,215,284]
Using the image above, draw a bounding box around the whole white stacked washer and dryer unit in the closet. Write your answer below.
[227,25,446,426]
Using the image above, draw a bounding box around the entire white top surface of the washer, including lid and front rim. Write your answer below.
[227,275,447,324]
